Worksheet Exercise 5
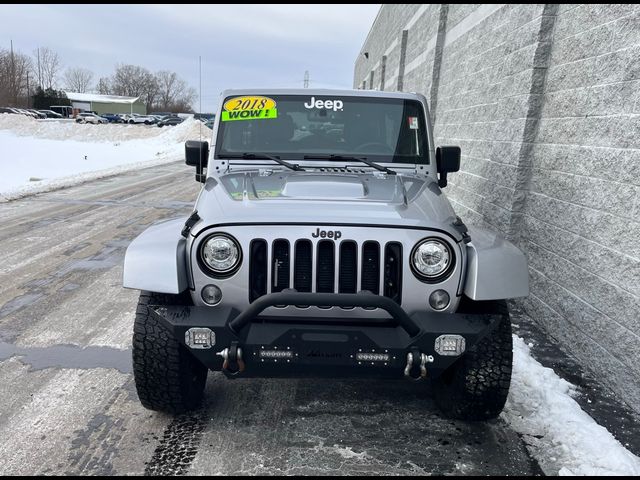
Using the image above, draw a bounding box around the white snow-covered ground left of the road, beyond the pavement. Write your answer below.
[0,113,211,201]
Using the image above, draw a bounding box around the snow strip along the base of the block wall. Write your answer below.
[502,335,640,476]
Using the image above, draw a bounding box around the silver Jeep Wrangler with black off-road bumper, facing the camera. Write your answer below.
[124,89,529,420]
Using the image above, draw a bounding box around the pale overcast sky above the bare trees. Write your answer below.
[0,5,379,111]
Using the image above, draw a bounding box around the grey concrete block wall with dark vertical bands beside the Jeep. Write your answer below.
[354,4,640,411]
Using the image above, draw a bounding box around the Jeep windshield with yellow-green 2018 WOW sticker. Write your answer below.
[216,95,429,164]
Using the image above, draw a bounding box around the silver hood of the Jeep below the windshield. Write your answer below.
[192,168,456,240]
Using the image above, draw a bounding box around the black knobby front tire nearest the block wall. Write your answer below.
[432,299,513,420]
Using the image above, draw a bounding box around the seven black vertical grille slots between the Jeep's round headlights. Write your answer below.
[249,239,402,303]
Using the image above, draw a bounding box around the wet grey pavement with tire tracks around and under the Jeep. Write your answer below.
[0,164,541,475]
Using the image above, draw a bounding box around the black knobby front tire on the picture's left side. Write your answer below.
[133,292,207,414]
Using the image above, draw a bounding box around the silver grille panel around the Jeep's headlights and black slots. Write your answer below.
[187,223,467,321]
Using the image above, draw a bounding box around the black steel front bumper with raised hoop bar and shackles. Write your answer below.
[151,292,503,378]
